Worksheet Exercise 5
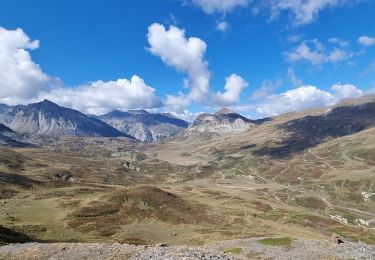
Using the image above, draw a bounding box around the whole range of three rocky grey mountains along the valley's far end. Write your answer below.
[0,100,274,142]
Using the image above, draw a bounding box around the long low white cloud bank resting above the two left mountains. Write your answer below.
[41,76,161,114]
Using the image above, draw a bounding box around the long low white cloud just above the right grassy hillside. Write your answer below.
[256,84,363,116]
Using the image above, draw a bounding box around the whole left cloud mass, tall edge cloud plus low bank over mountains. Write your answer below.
[0,28,161,114]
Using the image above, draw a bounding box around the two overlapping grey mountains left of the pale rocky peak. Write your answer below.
[0,100,189,142]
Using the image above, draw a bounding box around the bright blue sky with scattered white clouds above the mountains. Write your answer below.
[0,0,375,121]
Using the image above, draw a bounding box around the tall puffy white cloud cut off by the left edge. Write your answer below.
[0,27,54,104]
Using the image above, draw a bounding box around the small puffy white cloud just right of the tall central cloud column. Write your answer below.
[213,74,249,106]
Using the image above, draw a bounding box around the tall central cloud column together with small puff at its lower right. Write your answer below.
[147,23,247,112]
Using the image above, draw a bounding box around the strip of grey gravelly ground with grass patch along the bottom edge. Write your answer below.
[0,238,375,260]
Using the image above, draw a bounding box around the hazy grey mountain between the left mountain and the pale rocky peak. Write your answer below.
[98,110,188,142]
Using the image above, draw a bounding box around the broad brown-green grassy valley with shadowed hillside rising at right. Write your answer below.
[0,97,375,258]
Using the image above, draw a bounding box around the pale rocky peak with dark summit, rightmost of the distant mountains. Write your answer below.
[185,108,256,136]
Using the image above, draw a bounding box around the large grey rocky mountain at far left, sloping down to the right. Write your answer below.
[0,100,129,137]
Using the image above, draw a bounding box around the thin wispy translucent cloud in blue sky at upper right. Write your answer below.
[286,39,351,65]
